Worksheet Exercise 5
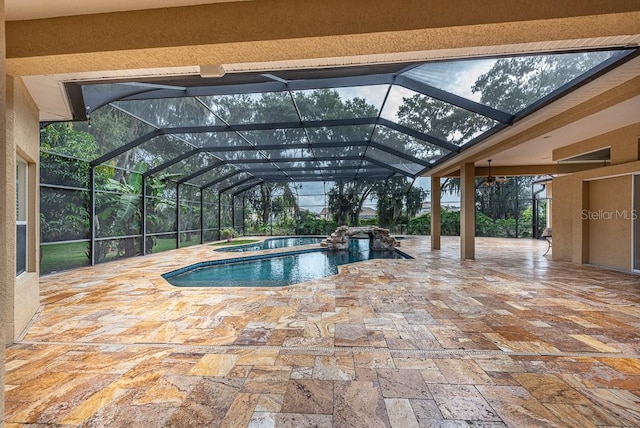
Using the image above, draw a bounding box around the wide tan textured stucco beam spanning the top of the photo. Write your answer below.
[7,0,640,76]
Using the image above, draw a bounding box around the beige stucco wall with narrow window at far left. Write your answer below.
[5,77,40,343]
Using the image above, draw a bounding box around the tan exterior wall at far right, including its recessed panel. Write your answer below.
[552,124,640,270]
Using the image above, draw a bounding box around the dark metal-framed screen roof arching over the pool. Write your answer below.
[56,49,638,195]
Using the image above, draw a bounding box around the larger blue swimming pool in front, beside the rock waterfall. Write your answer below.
[162,239,412,287]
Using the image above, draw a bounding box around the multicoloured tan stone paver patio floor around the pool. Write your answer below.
[5,237,640,428]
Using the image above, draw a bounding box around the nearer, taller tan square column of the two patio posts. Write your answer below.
[460,163,476,260]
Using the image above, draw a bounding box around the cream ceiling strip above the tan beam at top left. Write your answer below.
[4,0,250,21]
